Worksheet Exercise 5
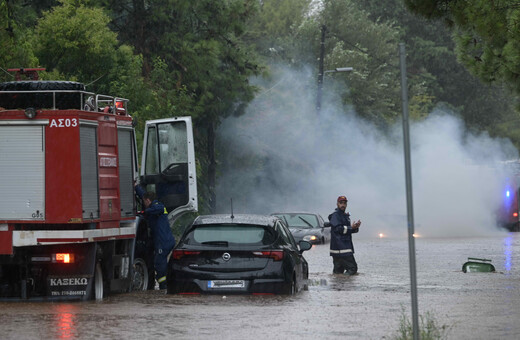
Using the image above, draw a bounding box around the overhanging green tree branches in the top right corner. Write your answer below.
[405,0,520,94]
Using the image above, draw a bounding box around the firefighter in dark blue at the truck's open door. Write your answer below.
[135,185,175,289]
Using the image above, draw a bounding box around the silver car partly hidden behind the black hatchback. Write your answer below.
[271,212,330,244]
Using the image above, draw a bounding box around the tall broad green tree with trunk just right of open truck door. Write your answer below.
[100,0,261,211]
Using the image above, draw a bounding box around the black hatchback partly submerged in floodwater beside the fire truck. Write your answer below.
[167,214,312,294]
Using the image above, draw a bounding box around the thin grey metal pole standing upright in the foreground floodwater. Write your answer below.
[399,43,419,340]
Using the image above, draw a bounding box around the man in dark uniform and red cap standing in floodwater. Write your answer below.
[329,196,361,275]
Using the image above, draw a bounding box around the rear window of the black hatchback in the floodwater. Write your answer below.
[185,224,276,246]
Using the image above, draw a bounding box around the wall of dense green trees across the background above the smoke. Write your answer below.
[0,0,520,212]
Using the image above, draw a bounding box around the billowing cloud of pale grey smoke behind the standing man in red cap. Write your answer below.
[217,68,517,237]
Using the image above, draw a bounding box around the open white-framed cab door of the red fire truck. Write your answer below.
[140,117,198,224]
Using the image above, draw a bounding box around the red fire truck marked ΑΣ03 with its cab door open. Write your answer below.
[0,69,197,300]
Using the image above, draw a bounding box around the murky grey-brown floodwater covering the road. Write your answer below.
[0,233,520,339]
